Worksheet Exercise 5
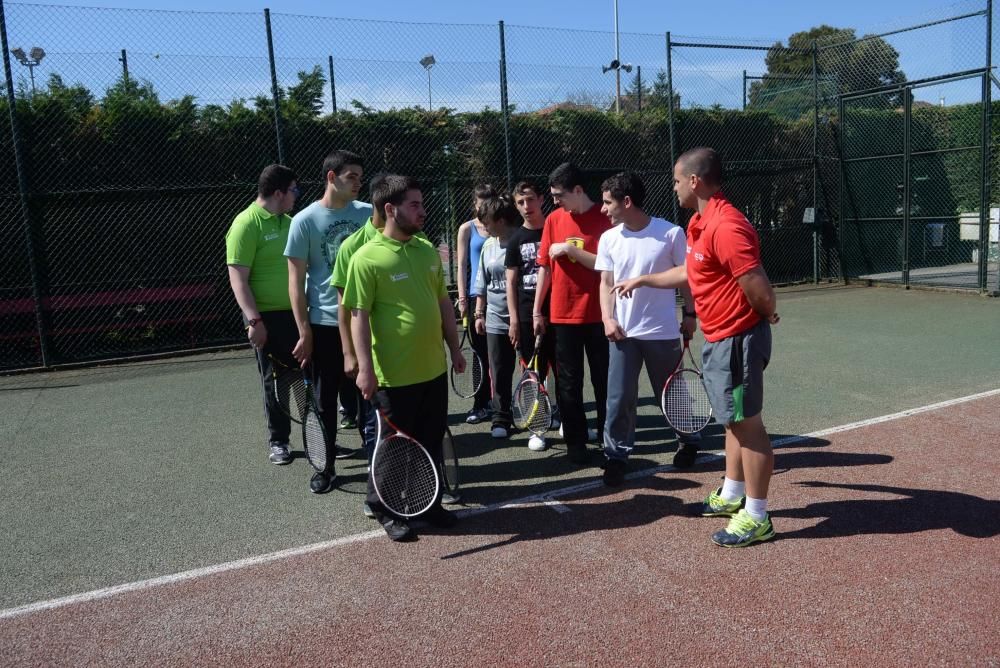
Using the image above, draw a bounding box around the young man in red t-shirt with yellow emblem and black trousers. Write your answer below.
[532,162,611,464]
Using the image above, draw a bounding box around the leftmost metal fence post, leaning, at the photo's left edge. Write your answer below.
[0,0,52,366]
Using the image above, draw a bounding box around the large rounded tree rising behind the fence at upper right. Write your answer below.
[748,25,906,117]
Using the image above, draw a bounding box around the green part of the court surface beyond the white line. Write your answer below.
[0,285,1000,609]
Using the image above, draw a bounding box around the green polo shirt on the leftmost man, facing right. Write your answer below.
[226,202,292,312]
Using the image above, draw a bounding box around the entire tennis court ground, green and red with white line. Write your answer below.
[0,286,1000,666]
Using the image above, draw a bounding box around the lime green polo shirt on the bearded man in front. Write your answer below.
[344,228,448,387]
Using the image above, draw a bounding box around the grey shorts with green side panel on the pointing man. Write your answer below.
[701,320,771,425]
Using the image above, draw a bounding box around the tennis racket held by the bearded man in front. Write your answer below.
[371,399,441,517]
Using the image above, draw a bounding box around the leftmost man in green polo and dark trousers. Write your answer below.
[226,165,299,465]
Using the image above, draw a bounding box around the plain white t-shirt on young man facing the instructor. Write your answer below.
[594,218,687,339]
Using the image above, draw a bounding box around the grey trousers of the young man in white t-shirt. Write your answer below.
[604,339,701,461]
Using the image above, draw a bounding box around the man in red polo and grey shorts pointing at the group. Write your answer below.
[615,148,778,547]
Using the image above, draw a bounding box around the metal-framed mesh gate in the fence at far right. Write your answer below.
[840,71,1000,292]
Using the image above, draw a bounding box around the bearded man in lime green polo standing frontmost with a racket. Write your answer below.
[343,174,465,541]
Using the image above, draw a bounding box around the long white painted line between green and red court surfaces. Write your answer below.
[0,388,1000,619]
